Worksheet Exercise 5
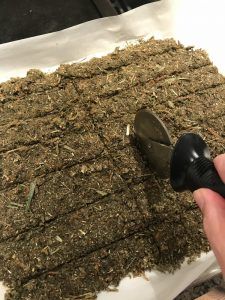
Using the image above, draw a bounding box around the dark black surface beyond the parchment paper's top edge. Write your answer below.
[0,0,158,44]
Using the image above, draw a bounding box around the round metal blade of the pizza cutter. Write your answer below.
[134,109,173,178]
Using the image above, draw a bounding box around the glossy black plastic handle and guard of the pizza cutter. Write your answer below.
[170,133,225,198]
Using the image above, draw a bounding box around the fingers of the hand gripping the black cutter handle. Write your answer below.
[193,154,225,278]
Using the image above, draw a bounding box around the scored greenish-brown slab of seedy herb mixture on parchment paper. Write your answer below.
[0,39,225,300]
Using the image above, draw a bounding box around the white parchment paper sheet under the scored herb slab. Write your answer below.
[0,0,225,300]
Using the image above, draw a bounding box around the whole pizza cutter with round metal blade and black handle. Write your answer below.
[134,109,225,198]
